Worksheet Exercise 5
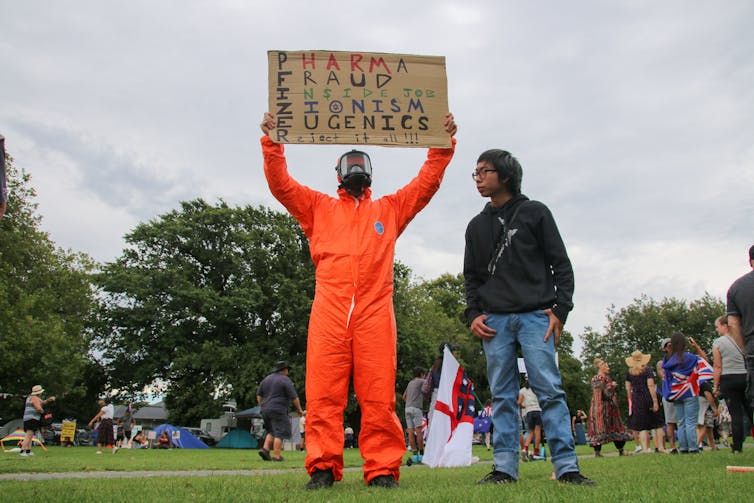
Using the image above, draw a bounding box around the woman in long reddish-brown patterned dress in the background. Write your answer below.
[588,358,631,458]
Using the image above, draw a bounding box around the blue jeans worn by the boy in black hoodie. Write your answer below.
[484,311,579,479]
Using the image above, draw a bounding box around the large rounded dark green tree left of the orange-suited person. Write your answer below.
[96,199,314,424]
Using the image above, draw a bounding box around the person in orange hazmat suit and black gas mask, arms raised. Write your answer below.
[261,112,457,489]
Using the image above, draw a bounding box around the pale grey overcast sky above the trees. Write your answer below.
[0,0,754,354]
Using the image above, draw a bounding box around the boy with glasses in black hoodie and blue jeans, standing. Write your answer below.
[463,149,595,485]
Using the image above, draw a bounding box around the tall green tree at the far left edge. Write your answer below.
[0,152,95,424]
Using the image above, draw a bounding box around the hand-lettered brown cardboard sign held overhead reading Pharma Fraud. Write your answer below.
[267,51,451,148]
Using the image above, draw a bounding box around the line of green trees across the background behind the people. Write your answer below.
[0,153,724,426]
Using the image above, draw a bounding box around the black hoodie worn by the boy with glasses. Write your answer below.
[463,194,574,324]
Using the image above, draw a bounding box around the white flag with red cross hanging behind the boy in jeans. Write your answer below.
[422,346,475,468]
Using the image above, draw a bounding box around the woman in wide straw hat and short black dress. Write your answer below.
[626,350,665,454]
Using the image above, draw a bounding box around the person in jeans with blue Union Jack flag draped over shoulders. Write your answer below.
[662,332,712,454]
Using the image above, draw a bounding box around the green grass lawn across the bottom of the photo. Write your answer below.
[0,445,754,503]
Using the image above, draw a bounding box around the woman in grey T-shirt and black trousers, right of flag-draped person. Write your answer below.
[712,315,751,452]
